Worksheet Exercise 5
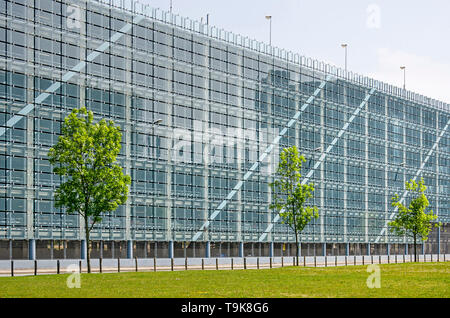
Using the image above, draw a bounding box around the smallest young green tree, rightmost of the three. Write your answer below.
[388,178,441,262]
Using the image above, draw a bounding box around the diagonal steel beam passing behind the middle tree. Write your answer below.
[259,88,375,242]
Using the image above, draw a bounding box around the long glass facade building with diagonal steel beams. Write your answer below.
[0,0,450,259]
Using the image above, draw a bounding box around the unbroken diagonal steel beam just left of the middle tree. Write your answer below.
[192,75,332,241]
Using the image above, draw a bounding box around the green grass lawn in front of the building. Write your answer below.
[0,262,450,298]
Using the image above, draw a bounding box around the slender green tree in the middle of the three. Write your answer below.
[270,146,319,266]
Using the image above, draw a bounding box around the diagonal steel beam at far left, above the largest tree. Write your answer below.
[0,15,144,137]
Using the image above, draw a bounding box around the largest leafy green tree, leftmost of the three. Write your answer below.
[48,107,131,273]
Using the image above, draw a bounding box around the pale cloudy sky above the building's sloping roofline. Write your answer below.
[140,0,450,103]
